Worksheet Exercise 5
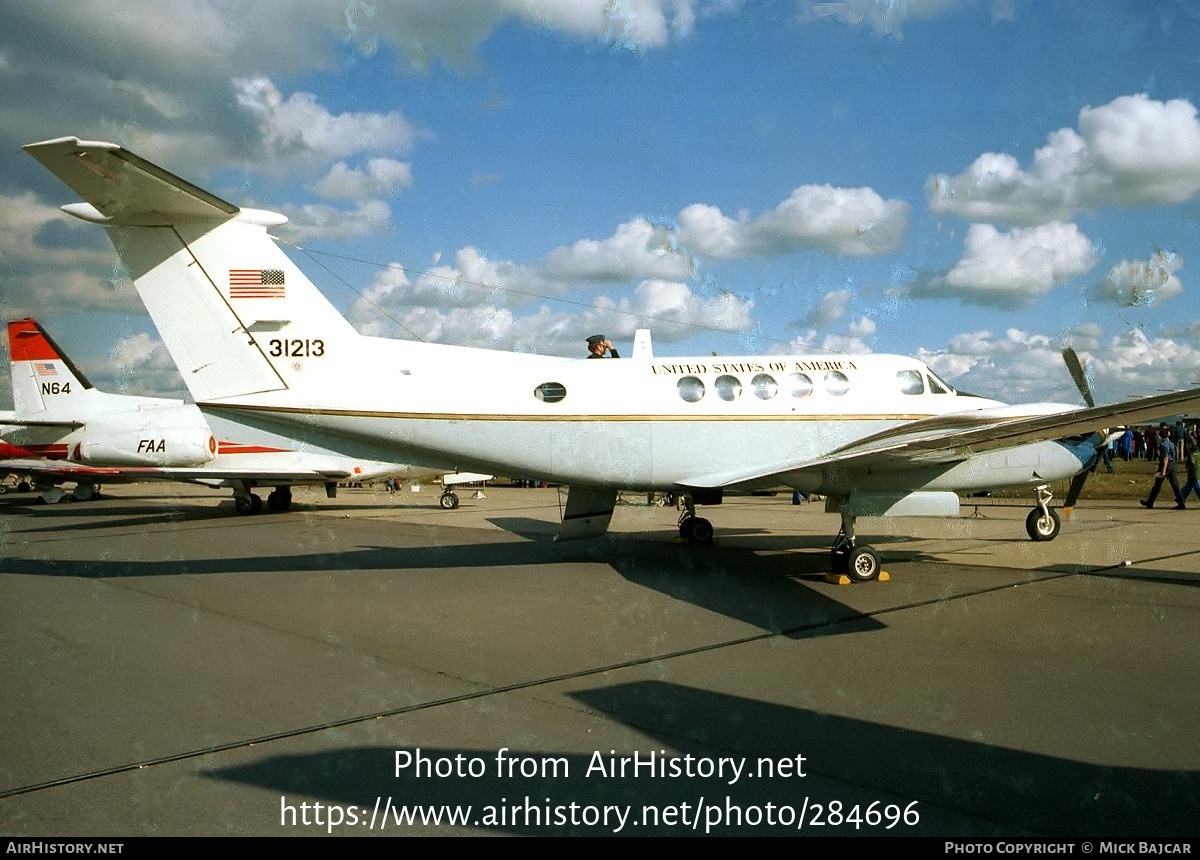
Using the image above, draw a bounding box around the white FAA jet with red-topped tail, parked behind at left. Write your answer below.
[0,319,422,513]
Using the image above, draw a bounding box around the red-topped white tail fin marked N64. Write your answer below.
[8,319,97,420]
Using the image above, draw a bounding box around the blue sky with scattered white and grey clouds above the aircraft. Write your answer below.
[0,0,1200,402]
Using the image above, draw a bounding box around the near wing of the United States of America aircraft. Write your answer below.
[686,389,1200,489]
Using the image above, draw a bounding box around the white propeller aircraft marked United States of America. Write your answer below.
[25,138,1200,581]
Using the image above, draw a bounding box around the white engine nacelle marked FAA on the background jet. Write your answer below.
[68,426,217,468]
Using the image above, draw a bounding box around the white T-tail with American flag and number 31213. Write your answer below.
[25,138,359,403]
